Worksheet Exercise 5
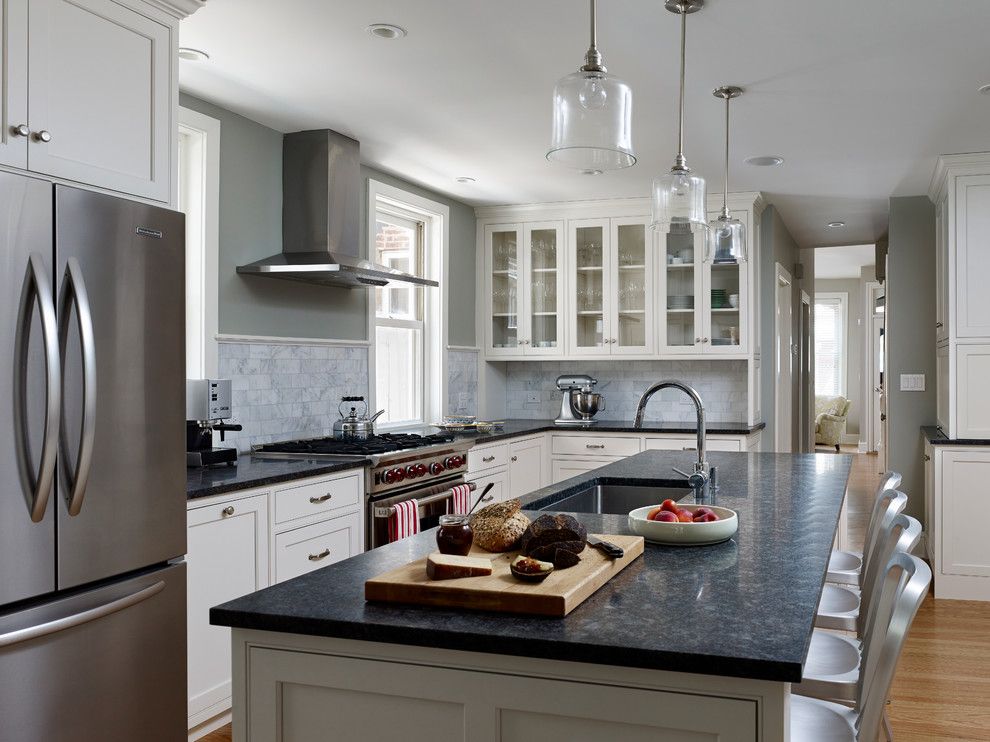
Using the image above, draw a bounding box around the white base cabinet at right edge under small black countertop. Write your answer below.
[925,444,990,600]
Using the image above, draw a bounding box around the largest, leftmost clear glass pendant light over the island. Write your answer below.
[547,0,636,175]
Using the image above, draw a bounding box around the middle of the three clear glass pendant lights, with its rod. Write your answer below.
[652,0,708,232]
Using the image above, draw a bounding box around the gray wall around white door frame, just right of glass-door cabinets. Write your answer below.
[759,206,814,451]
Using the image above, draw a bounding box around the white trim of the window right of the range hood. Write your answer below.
[366,178,450,430]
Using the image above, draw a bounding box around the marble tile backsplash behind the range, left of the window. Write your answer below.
[219,342,369,451]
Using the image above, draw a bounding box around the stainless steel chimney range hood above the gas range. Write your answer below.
[237,129,440,288]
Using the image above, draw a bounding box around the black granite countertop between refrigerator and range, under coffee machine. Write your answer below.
[186,453,371,500]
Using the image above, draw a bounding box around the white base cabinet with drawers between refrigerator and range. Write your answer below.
[186,469,364,739]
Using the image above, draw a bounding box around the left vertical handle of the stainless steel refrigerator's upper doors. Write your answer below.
[14,253,62,523]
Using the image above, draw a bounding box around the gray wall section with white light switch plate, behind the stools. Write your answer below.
[886,196,936,527]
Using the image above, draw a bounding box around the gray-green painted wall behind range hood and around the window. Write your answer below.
[179,93,475,346]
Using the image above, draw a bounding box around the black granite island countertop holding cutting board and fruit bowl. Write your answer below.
[210,451,851,682]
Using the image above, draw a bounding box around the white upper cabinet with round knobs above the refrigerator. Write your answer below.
[0,0,193,203]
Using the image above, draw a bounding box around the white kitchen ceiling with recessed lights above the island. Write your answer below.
[180,0,990,247]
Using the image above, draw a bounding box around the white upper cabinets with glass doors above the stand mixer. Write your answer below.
[478,193,763,360]
